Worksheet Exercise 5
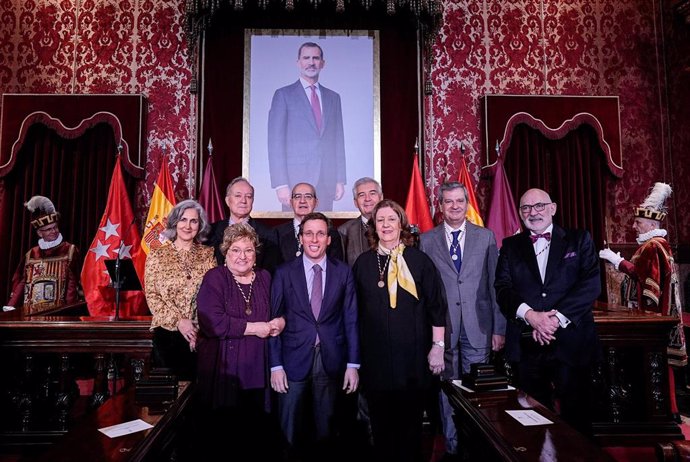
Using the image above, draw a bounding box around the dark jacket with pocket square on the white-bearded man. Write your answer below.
[495,225,601,366]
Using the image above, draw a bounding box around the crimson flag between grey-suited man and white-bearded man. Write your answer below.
[486,157,520,249]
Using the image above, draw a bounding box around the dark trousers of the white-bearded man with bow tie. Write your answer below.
[516,337,592,435]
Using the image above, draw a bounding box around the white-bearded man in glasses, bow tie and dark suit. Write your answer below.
[495,189,601,433]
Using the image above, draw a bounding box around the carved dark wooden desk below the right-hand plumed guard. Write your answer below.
[592,304,684,446]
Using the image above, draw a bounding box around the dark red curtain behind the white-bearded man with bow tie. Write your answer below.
[505,124,613,300]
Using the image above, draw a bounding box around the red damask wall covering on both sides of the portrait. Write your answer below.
[0,0,690,247]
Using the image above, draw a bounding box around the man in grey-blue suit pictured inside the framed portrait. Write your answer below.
[268,42,347,211]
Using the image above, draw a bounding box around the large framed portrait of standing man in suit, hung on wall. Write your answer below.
[242,29,381,218]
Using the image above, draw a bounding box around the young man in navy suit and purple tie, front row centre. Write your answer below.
[268,213,359,452]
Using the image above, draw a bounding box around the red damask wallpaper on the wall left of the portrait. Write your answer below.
[0,0,196,216]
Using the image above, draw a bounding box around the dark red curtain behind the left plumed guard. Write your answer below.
[0,124,135,303]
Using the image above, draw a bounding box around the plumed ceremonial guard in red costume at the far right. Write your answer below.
[599,183,687,414]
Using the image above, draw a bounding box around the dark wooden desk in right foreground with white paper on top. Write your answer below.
[441,381,613,462]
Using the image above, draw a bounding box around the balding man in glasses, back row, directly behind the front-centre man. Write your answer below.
[276,183,343,262]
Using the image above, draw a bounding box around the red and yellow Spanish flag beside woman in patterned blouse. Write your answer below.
[141,156,176,255]
